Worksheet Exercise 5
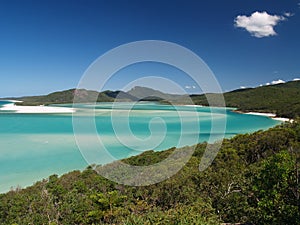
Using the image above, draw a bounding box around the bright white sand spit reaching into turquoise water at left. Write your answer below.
[0,103,75,113]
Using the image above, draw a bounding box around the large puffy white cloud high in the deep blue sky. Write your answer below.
[234,11,286,38]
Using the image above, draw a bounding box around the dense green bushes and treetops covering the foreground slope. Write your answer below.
[0,119,300,225]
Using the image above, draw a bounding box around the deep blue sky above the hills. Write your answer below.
[0,0,300,97]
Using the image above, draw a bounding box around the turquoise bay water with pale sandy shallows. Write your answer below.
[0,102,280,192]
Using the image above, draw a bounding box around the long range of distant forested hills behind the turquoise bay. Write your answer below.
[2,81,300,118]
